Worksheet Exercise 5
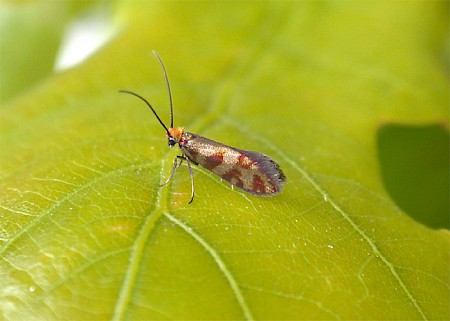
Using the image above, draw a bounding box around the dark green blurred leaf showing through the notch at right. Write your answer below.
[378,125,450,229]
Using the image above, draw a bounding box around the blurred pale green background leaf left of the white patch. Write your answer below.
[0,1,89,103]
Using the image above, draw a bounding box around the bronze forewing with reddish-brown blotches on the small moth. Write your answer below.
[180,133,286,196]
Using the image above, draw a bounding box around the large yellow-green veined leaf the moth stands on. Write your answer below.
[0,1,450,320]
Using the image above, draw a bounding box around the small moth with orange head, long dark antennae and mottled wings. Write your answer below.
[120,51,286,204]
